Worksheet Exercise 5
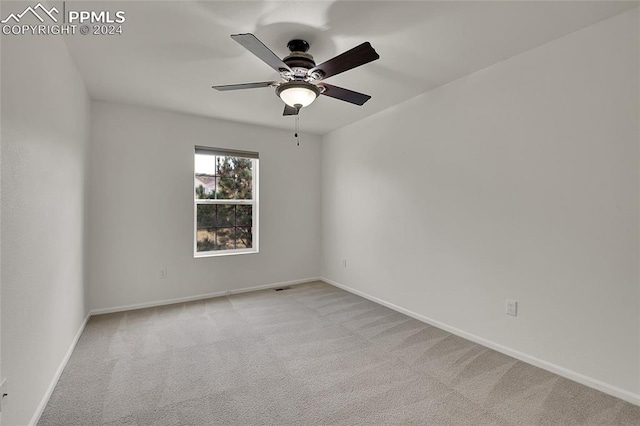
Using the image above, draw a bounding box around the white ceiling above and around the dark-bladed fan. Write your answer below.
[65,1,638,134]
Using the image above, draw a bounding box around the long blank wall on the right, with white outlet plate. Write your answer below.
[322,9,640,403]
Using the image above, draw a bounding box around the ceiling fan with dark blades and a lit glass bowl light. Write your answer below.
[213,34,380,115]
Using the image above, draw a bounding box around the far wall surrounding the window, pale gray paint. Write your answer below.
[89,102,320,309]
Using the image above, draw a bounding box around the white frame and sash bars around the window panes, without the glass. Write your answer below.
[191,145,260,258]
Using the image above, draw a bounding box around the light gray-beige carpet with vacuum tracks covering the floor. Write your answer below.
[38,282,640,426]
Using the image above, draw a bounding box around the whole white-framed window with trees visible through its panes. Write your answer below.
[194,146,258,257]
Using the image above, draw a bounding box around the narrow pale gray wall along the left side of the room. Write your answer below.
[0,24,90,425]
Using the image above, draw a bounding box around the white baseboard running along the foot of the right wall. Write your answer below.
[321,278,640,405]
